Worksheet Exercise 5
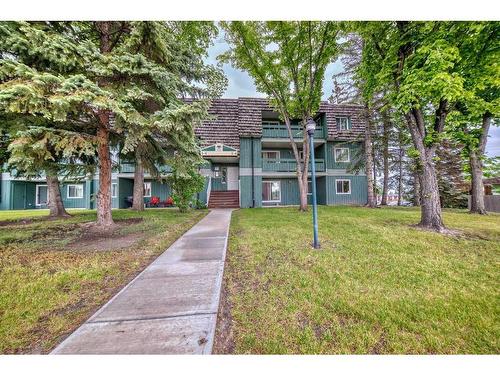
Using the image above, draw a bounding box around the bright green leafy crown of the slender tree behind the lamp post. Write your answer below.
[221,21,339,119]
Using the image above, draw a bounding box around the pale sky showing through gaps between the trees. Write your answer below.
[207,34,500,156]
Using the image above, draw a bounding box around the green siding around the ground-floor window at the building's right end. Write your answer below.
[326,176,368,205]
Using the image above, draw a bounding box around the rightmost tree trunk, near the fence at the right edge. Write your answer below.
[469,113,491,215]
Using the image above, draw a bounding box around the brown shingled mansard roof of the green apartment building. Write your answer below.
[195,98,366,149]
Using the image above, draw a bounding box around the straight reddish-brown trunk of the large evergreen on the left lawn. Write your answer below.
[96,21,114,228]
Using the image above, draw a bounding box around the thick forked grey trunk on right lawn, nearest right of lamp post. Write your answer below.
[405,109,445,232]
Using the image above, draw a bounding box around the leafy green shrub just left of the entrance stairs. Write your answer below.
[167,157,205,212]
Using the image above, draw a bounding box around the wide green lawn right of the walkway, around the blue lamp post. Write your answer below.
[215,207,500,354]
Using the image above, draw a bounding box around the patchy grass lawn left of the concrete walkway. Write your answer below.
[0,209,207,353]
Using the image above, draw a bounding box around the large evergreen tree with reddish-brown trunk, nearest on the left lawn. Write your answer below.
[0,21,224,228]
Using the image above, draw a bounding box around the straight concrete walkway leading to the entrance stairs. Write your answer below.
[52,209,232,354]
